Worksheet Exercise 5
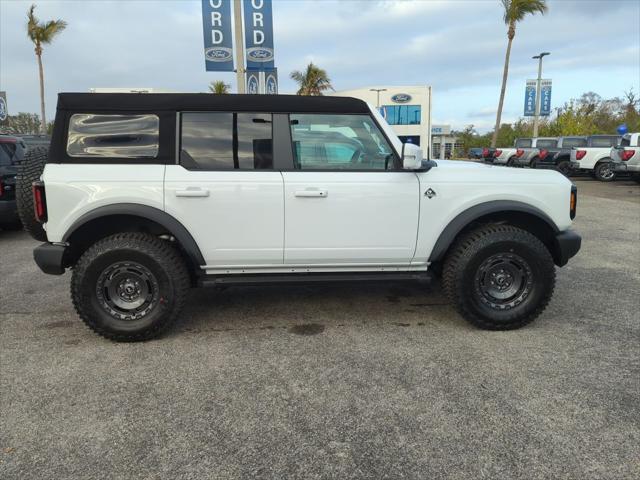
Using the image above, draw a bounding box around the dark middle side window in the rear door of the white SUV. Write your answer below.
[180,112,273,171]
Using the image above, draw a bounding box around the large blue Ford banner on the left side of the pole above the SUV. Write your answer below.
[202,0,233,72]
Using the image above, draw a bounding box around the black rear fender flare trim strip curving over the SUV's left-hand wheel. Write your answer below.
[62,203,205,266]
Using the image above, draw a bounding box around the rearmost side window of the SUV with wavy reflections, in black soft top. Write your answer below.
[67,113,160,158]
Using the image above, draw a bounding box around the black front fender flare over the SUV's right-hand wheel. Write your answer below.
[429,200,559,262]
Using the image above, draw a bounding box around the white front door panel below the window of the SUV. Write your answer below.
[283,171,420,266]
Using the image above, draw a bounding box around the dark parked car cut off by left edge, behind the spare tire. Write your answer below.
[0,135,27,230]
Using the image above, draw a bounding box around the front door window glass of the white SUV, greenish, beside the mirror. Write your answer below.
[290,114,395,170]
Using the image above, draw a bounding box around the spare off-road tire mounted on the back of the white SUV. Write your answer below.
[16,147,49,242]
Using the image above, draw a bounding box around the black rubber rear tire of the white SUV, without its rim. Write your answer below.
[71,233,190,342]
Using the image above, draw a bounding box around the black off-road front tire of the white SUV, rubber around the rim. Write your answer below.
[442,225,556,330]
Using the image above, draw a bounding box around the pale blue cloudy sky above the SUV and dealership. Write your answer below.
[0,0,640,130]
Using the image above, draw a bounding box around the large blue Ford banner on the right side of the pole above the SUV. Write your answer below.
[244,0,275,71]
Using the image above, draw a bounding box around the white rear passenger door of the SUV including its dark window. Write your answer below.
[164,112,284,270]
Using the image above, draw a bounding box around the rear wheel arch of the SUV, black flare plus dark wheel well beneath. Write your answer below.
[62,203,205,272]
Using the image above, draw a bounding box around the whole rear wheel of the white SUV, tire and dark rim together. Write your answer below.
[71,233,189,342]
